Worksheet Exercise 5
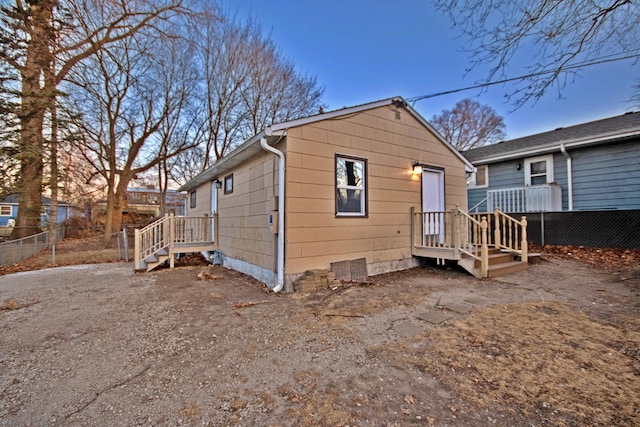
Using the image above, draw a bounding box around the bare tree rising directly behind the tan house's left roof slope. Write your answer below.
[175,9,323,182]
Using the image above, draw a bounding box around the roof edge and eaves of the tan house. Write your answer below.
[178,96,473,191]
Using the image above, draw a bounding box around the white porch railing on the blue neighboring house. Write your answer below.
[487,184,562,212]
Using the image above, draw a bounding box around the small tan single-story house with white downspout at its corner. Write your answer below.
[136,97,528,291]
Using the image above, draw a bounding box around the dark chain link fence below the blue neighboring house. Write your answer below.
[509,210,640,249]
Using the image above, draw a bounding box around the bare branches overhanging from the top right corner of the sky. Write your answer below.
[434,0,640,106]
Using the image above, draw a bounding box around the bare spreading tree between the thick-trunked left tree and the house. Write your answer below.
[70,29,194,242]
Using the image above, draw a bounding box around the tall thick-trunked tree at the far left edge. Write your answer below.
[0,0,183,237]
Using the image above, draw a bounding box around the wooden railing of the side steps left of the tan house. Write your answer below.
[134,214,218,270]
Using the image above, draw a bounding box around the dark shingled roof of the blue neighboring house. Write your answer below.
[462,112,640,164]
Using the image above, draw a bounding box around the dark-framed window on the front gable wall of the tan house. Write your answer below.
[336,155,367,216]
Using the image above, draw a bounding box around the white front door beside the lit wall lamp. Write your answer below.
[422,167,444,244]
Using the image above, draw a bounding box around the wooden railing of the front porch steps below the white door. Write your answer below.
[411,207,528,277]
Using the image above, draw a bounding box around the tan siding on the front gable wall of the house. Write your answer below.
[286,107,466,275]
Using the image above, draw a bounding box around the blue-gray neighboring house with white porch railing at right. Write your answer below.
[462,112,640,213]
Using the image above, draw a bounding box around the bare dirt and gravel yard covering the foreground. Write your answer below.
[0,249,640,426]
